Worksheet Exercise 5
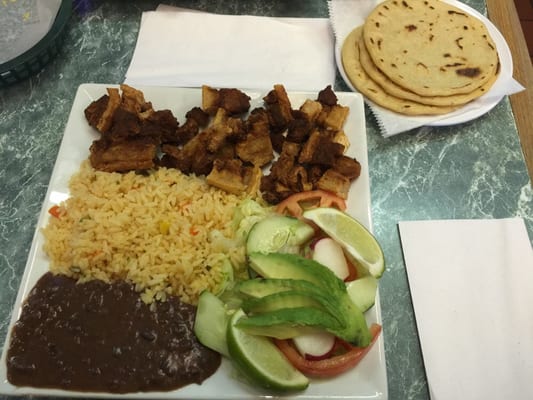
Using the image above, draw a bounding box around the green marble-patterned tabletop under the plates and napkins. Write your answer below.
[0,0,533,400]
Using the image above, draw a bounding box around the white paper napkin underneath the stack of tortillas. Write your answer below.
[328,0,525,137]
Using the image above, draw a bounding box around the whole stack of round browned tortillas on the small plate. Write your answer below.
[341,0,499,115]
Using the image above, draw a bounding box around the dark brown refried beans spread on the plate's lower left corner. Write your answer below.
[7,272,221,393]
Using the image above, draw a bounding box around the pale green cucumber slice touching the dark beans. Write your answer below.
[194,291,230,357]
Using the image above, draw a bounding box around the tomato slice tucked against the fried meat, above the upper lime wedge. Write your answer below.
[276,190,346,217]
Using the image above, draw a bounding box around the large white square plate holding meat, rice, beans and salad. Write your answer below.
[0,84,387,399]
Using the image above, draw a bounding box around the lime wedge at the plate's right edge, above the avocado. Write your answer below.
[303,207,385,278]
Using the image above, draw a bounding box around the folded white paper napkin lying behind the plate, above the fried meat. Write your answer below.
[125,6,335,91]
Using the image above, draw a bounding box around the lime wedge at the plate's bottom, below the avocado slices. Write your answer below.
[227,310,309,391]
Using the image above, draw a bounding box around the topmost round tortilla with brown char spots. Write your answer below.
[363,0,499,96]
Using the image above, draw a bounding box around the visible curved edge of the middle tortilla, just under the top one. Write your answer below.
[359,36,498,106]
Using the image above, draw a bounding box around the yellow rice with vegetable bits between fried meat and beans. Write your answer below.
[43,161,251,304]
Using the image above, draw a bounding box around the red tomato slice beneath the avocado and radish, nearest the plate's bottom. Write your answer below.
[274,323,381,378]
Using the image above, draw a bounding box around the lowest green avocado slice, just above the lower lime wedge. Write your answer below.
[237,307,342,339]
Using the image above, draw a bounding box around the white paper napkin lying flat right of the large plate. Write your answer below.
[399,218,533,400]
